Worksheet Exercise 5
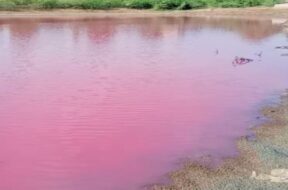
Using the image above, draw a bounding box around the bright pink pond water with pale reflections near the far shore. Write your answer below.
[0,17,288,190]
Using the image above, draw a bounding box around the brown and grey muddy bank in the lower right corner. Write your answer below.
[152,91,288,190]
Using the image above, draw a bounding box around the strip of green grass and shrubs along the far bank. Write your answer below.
[0,0,281,10]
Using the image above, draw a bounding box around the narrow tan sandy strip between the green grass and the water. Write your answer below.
[0,7,288,19]
